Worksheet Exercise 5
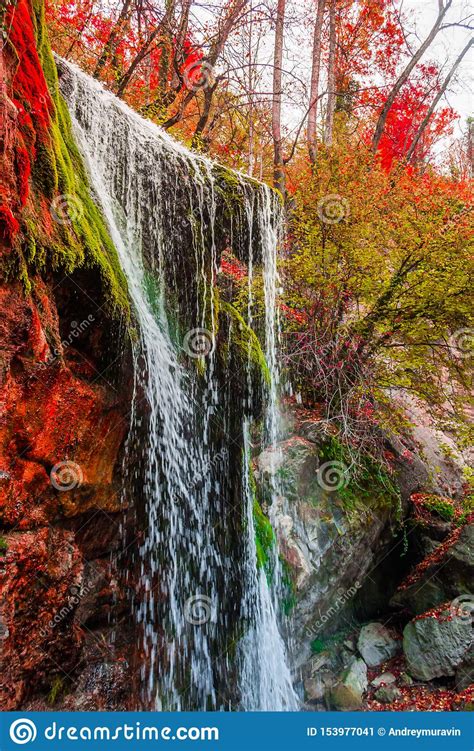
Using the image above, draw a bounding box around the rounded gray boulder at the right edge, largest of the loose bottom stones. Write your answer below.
[403,603,472,681]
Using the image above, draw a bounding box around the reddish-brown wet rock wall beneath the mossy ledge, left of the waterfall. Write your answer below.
[0,270,130,710]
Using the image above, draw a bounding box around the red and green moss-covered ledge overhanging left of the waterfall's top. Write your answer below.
[0,0,129,315]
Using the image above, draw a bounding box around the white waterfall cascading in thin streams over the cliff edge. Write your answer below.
[58,61,297,710]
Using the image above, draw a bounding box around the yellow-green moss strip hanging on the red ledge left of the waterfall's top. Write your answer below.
[15,0,129,313]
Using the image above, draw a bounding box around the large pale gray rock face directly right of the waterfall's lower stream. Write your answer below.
[255,435,392,667]
